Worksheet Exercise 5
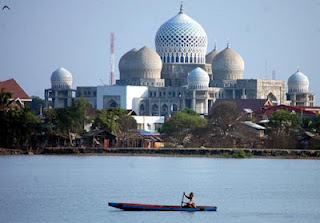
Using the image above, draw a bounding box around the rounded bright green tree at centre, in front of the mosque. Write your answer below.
[160,108,207,144]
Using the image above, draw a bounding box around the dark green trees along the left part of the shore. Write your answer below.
[0,89,137,149]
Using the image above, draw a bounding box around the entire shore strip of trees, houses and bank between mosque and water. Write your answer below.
[0,89,320,159]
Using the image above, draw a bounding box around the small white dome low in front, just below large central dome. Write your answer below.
[187,67,210,89]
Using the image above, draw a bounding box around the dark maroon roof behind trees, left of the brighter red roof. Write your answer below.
[209,99,268,114]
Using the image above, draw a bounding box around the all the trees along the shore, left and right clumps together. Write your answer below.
[0,89,320,148]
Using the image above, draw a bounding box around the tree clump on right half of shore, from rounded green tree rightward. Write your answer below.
[160,102,320,149]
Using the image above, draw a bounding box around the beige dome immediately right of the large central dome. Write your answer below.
[212,44,244,80]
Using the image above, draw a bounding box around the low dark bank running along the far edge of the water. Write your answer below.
[0,147,320,159]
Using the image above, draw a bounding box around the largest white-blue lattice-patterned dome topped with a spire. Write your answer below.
[155,6,208,64]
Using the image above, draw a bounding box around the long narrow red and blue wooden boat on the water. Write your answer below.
[108,202,217,211]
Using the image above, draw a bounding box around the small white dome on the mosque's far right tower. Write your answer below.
[288,69,309,93]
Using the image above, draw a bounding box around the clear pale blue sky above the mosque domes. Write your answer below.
[0,0,320,105]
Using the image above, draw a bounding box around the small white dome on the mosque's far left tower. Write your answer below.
[51,67,72,89]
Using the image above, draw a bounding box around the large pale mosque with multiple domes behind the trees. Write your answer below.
[45,5,315,117]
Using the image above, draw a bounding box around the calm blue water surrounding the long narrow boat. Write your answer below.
[0,156,320,223]
